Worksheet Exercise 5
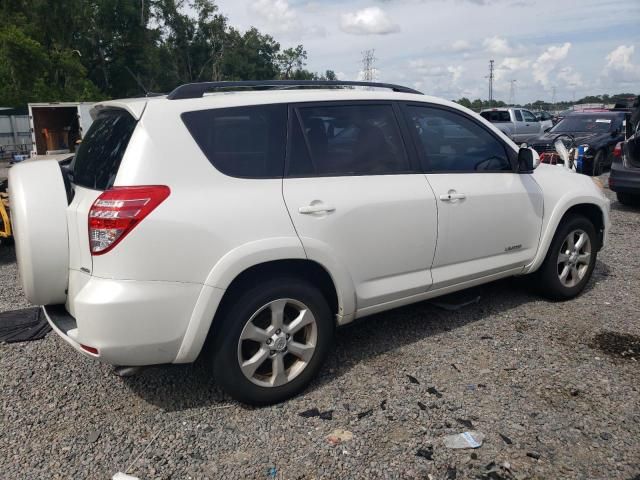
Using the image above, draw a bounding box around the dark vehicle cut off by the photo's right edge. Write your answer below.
[609,123,640,206]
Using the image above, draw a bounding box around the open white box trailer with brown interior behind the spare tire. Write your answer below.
[29,102,93,158]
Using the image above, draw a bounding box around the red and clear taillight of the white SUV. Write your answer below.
[89,185,171,255]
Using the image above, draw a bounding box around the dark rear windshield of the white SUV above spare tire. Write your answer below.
[71,109,136,190]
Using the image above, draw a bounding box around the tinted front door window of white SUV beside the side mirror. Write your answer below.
[408,106,512,172]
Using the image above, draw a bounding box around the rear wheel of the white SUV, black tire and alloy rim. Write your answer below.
[212,277,335,405]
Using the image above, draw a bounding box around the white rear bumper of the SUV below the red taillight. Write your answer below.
[43,271,202,366]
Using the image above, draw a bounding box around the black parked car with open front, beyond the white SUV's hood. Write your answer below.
[530,111,629,175]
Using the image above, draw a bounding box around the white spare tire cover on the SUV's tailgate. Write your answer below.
[9,160,69,305]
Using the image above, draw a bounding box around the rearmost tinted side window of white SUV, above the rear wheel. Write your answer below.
[182,105,287,178]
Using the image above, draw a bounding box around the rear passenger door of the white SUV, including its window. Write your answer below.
[283,102,437,314]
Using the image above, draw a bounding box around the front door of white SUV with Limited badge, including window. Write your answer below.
[404,104,543,289]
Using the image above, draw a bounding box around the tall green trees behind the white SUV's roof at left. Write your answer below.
[0,0,335,107]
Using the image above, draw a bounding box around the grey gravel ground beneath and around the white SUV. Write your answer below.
[0,176,640,480]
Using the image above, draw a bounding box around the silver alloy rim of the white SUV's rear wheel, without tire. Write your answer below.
[238,298,318,387]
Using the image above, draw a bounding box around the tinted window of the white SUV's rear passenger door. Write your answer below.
[288,105,410,176]
